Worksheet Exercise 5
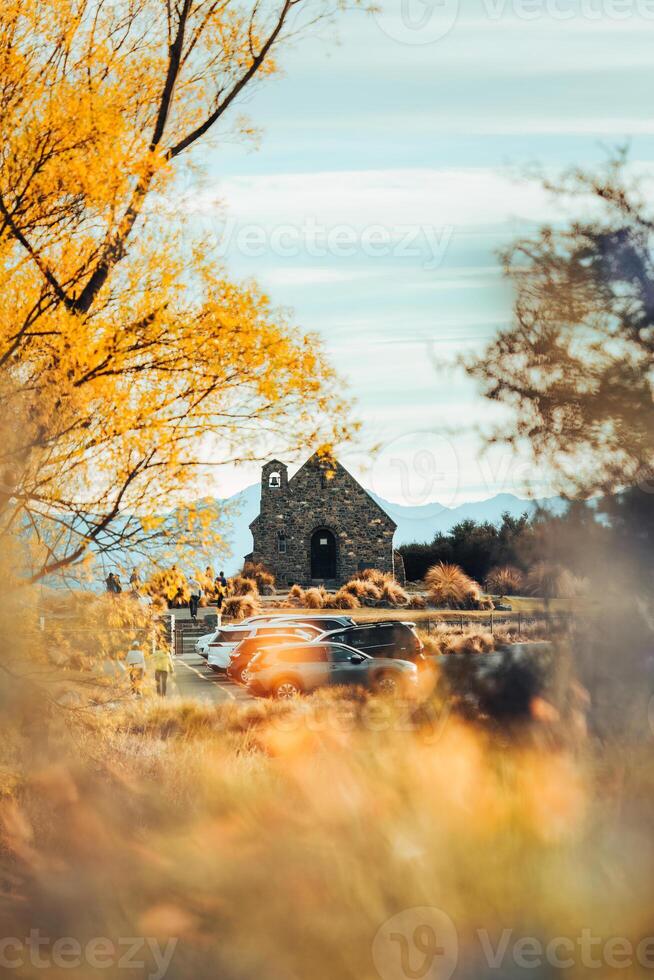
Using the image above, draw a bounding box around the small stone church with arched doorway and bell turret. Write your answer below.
[247,454,403,586]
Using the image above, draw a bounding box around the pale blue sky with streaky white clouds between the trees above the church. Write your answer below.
[185,0,654,506]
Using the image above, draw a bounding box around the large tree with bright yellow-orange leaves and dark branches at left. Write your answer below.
[0,0,356,580]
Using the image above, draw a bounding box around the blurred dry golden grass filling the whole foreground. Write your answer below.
[0,572,654,980]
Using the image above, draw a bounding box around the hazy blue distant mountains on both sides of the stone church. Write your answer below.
[218,483,566,575]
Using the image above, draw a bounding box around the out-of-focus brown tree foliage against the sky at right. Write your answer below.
[466,153,654,493]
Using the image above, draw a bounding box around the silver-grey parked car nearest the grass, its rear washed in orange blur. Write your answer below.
[247,641,418,698]
